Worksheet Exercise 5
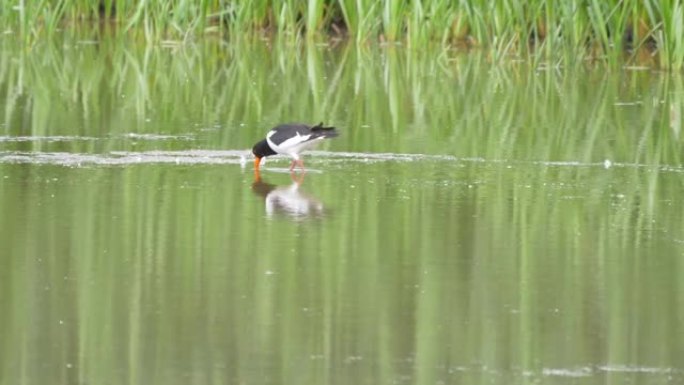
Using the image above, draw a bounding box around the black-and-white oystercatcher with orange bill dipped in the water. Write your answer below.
[252,122,339,171]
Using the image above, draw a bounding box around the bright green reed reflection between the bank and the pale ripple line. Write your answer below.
[0,36,684,165]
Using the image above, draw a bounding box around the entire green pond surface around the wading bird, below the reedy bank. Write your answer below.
[0,34,684,384]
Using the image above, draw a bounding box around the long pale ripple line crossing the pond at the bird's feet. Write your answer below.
[0,150,684,173]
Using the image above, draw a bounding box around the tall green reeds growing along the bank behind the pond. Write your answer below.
[0,0,684,69]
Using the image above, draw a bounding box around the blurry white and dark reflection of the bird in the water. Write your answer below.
[252,171,325,220]
